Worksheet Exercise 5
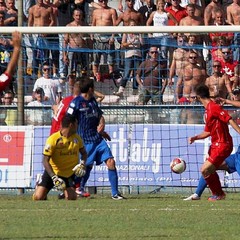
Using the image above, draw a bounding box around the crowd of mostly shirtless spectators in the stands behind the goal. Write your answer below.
[0,0,240,124]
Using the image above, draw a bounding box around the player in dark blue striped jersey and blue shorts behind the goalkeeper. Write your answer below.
[67,77,123,200]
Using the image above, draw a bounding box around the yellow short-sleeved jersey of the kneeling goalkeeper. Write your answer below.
[43,131,83,178]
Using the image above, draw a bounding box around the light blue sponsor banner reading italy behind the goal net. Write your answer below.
[33,124,240,187]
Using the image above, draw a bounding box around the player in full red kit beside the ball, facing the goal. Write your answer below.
[188,85,240,201]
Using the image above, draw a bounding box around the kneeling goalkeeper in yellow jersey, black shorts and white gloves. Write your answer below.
[33,115,87,200]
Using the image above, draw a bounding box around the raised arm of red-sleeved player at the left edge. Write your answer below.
[0,31,22,92]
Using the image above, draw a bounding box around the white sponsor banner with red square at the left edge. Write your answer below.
[0,126,33,188]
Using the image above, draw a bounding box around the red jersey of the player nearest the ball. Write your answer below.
[204,101,233,146]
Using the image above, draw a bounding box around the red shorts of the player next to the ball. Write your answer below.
[207,143,233,168]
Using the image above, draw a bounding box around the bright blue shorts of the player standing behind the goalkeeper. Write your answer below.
[84,139,113,166]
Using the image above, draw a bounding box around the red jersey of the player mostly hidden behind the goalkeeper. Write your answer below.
[50,96,74,135]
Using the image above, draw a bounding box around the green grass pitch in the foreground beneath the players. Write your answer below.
[0,193,240,240]
